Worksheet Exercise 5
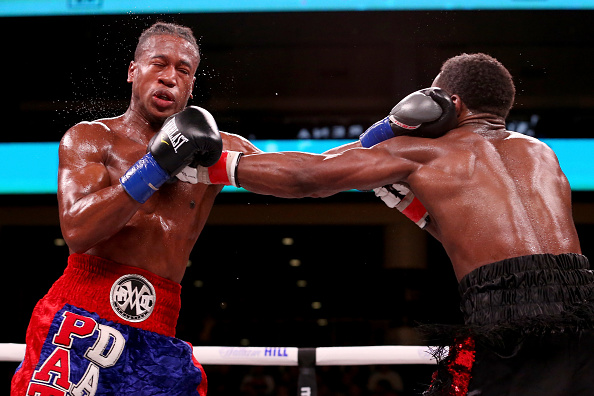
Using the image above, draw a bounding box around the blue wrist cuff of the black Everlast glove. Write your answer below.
[120,153,170,203]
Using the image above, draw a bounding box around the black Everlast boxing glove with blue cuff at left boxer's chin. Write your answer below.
[120,106,223,203]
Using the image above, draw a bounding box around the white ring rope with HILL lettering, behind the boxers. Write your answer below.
[0,343,436,366]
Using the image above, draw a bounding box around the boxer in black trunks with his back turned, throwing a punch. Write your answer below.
[200,54,594,396]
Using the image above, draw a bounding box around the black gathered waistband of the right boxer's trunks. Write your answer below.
[459,254,594,330]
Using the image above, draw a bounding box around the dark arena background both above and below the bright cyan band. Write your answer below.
[0,11,594,395]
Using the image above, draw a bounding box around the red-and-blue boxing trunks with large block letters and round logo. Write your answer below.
[11,254,207,396]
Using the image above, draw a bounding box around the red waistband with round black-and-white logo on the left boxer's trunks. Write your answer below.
[46,254,181,337]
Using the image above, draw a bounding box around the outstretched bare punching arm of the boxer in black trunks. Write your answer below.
[236,137,421,198]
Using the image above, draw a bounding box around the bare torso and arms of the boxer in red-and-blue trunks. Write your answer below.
[58,115,254,282]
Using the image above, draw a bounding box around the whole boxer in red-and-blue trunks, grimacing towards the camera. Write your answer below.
[12,22,257,396]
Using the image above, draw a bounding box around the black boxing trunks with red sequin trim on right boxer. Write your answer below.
[423,254,594,396]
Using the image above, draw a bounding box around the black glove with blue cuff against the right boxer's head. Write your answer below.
[359,88,458,147]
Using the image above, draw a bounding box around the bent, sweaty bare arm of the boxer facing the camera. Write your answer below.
[58,123,141,253]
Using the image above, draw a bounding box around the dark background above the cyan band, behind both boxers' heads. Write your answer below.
[0,11,594,141]
